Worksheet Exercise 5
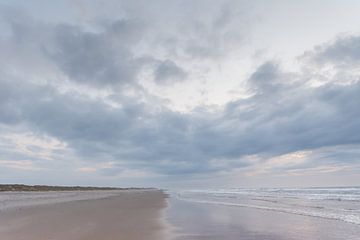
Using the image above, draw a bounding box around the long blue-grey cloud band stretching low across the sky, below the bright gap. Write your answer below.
[2,63,360,174]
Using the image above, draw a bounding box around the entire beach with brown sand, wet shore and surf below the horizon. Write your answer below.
[0,188,360,240]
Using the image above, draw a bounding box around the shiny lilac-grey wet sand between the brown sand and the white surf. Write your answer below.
[168,197,360,240]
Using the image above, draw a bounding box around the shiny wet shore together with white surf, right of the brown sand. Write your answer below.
[168,188,360,240]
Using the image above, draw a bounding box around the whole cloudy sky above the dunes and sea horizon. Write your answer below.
[0,0,360,188]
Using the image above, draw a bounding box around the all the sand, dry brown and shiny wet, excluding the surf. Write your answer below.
[0,190,360,240]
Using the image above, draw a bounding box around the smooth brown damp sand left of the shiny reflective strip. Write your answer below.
[0,190,168,240]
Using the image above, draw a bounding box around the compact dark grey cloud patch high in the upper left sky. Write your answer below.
[49,20,142,87]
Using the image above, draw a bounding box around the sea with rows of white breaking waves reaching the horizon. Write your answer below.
[176,187,360,226]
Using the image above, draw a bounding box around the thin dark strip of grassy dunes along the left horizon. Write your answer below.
[0,184,154,192]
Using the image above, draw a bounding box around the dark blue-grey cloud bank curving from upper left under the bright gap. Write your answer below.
[0,1,360,178]
